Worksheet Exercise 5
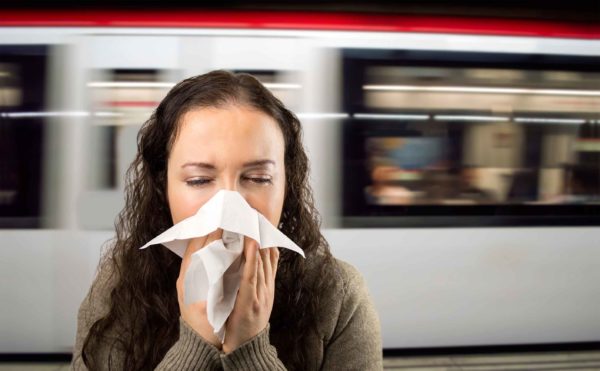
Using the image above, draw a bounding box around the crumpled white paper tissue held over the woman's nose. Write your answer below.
[141,190,304,342]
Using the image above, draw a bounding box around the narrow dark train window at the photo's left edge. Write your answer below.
[0,45,47,228]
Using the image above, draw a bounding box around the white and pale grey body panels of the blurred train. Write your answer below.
[0,21,600,353]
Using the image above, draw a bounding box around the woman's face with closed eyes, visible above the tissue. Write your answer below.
[167,105,285,226]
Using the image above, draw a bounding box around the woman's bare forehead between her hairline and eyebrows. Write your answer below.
[171,105,284,162]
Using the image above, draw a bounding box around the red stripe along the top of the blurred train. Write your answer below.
[0,10,600,39]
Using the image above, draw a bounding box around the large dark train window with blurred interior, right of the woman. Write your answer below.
[343,49,600,227]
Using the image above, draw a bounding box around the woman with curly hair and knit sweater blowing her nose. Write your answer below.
[72,71,381,370]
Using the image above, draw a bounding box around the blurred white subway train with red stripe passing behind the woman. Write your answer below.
[0,11,600,354]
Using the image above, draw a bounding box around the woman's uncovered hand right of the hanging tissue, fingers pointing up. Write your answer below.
[223,237,279,353]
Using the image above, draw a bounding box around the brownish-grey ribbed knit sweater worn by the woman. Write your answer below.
[71,259,382,371]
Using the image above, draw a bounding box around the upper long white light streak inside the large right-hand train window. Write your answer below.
[363,85,600,97]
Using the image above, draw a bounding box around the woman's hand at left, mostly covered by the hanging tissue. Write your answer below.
[177,229,223,349]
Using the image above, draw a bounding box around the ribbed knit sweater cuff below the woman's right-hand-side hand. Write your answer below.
[221,325,286,371]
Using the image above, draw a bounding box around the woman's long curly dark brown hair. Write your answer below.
[82,71,334,370]
